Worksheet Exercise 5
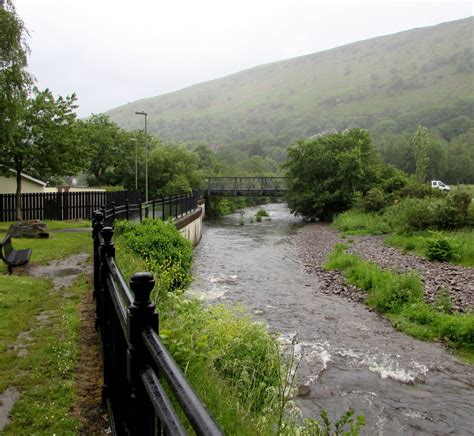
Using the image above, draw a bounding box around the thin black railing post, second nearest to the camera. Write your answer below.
[97,227,115,405]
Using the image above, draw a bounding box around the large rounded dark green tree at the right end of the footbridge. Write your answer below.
[284,129,382,220]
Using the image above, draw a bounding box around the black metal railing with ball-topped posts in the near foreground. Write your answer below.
[92,211,222,435]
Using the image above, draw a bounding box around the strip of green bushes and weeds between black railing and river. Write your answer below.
[115,220,363,435]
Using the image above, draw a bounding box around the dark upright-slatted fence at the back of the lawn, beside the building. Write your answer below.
[0,191,140,221]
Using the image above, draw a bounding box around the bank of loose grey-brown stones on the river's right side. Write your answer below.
[296,223,474,312]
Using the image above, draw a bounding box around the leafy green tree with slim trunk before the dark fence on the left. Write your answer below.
[0,88,83,220]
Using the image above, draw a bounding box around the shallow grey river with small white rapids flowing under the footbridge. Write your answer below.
[190,204,474,435]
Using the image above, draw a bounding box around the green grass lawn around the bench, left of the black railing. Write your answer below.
[0,222,92,435]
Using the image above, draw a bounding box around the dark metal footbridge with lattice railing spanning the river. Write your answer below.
[207,177,287,195]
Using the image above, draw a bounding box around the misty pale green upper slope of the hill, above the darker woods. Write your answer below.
[108,17,474,146]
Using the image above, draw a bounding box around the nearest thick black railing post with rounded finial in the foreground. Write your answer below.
[127,272,158,435]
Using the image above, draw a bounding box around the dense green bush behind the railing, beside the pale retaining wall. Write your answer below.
[115,218,192,299]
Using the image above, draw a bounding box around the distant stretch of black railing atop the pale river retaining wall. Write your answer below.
[103,191,200,224]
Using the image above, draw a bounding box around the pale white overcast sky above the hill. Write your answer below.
[14,0,473,117]
